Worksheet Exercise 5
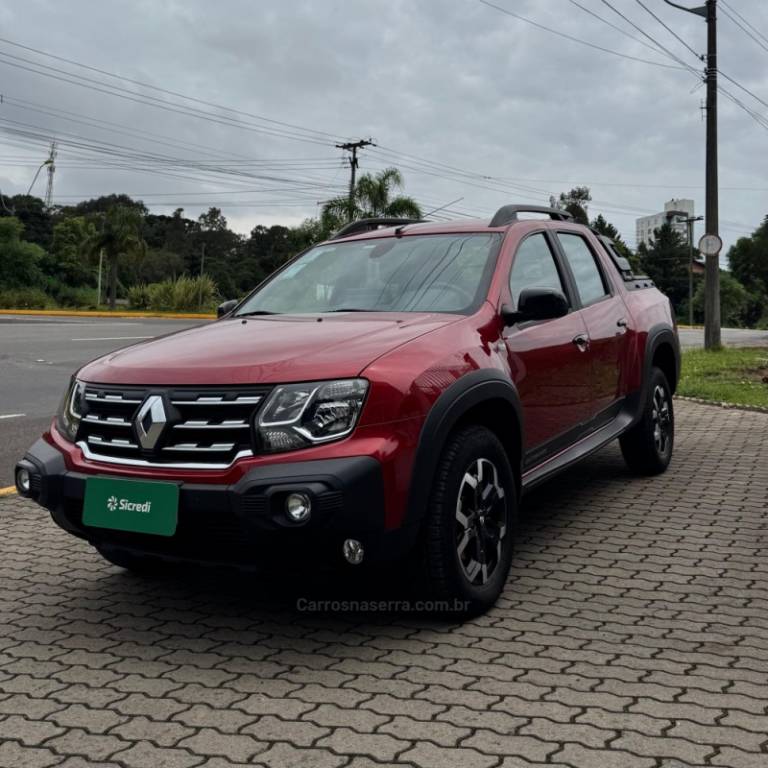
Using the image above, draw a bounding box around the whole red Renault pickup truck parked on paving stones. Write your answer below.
[16,205,680,613]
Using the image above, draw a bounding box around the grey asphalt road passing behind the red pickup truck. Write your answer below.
[0,316,768,488]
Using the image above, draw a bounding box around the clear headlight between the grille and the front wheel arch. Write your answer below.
[256,379,368,453]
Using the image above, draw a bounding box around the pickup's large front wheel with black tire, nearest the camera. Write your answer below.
[419,426,517,616]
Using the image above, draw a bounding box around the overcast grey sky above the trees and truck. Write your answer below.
[0,0,768,245]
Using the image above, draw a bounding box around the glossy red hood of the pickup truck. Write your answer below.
[79,312,463,386]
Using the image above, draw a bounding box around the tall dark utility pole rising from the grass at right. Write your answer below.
[664,0,720,349]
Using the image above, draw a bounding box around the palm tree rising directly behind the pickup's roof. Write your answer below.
[320,168,421,233]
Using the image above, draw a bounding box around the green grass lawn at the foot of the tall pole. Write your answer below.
[677,347,768,408]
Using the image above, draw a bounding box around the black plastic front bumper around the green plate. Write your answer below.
[17,440,399,566]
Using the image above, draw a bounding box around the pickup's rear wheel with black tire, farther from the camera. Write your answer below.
[619,368,675,475]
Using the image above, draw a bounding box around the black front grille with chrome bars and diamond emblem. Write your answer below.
[77,384,269,467]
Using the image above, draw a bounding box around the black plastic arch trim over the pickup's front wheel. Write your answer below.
[403,369,524,533]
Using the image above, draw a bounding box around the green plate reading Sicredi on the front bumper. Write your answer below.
[83,477,179,536]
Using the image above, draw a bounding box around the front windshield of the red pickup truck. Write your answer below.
[231,233,501,315]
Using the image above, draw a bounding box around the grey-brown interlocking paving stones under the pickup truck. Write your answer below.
[0,403,768,768]
